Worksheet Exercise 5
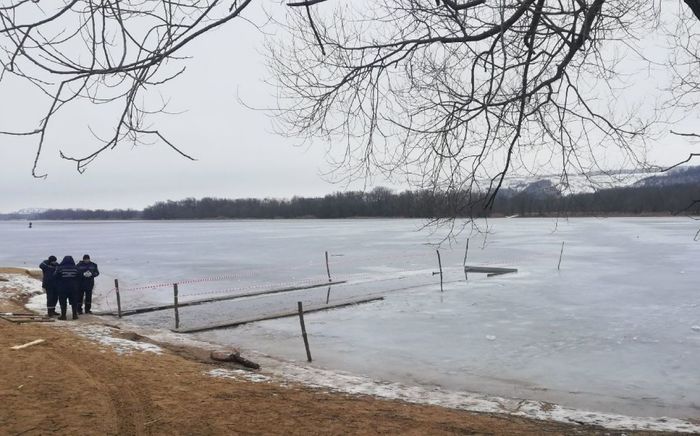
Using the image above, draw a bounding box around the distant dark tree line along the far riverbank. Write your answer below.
[0,181,700,220]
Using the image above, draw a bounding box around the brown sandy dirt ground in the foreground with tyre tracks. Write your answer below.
[0,272,684,435]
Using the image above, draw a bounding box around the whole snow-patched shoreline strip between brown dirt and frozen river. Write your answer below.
[0,268,700,432]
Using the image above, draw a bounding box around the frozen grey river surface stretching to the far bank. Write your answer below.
[0,218,700,418]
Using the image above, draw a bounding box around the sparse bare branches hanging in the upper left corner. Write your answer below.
[0,0,258,177]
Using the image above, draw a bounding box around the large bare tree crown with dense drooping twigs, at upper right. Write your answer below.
[269,0,700,207]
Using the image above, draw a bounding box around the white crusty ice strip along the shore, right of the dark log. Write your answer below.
[276,364,700,433]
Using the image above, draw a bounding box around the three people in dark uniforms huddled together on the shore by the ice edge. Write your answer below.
[39,254,100,320]
